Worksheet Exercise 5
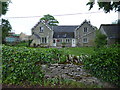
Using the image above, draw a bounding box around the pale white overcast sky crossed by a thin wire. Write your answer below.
[3,0,118,35]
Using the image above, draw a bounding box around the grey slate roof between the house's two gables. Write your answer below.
[53,25,78,38]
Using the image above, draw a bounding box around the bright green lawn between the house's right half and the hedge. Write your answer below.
[62,47,94,56]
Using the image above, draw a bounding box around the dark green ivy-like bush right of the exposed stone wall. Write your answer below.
[83,46,120,86]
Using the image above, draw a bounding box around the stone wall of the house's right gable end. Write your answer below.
[75,23,95,46]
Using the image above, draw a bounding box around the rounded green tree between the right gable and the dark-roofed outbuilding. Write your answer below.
[95,30,107,48]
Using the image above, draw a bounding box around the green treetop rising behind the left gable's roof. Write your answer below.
[40,14,59,26]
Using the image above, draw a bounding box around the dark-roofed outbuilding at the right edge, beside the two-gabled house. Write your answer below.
[99,24,120,45]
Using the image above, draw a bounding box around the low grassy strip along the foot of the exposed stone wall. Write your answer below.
[44,78,102,88]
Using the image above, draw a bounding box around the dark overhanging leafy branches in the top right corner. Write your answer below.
[86,0,120,13]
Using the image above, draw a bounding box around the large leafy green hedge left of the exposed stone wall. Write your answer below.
[2,46,66,84]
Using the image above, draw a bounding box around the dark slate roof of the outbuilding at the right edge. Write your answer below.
[100,24,120,38]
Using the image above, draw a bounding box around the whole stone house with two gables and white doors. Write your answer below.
[31,20,95,47]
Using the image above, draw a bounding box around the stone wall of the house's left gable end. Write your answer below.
[31,23,53,46]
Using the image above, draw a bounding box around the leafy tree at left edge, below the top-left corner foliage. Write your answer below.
[2,19,12,43]
